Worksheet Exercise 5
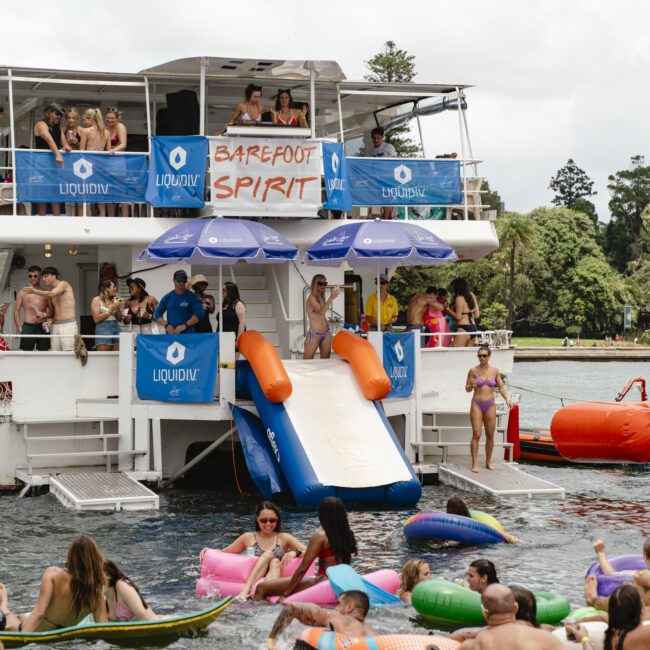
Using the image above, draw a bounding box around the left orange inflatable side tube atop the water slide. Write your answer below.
[237,330,293,404]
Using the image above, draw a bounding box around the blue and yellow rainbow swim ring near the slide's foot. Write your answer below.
[404,511,513,544]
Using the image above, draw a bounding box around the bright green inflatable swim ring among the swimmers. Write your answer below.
[411,578,571,625]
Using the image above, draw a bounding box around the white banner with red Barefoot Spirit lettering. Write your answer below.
[210,138,322,217]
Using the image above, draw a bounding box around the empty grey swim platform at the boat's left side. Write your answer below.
[50,472,160,511]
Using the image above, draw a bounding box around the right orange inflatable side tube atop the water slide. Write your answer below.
[332,330,390,400]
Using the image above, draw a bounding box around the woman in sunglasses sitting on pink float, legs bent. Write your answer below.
[213,501,306,600]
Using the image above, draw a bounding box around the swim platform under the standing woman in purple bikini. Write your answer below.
[438,458,565,498]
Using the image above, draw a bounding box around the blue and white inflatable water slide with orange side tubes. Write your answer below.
[233,331,422,508]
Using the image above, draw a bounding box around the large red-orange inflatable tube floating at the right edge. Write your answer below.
[551,402,650,463]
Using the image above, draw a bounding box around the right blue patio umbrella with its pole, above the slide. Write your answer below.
[304,219,458,330]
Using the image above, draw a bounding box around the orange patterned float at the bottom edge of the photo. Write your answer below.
[300,627,460,650]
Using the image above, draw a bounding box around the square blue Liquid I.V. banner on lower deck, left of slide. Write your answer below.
[135,334,219,402]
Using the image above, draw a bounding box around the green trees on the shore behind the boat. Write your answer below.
[366,41,650,336]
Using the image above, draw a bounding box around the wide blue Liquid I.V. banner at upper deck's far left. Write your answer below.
[16,151,147,203]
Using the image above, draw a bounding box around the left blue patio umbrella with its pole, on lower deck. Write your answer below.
[138,218,298,332]
